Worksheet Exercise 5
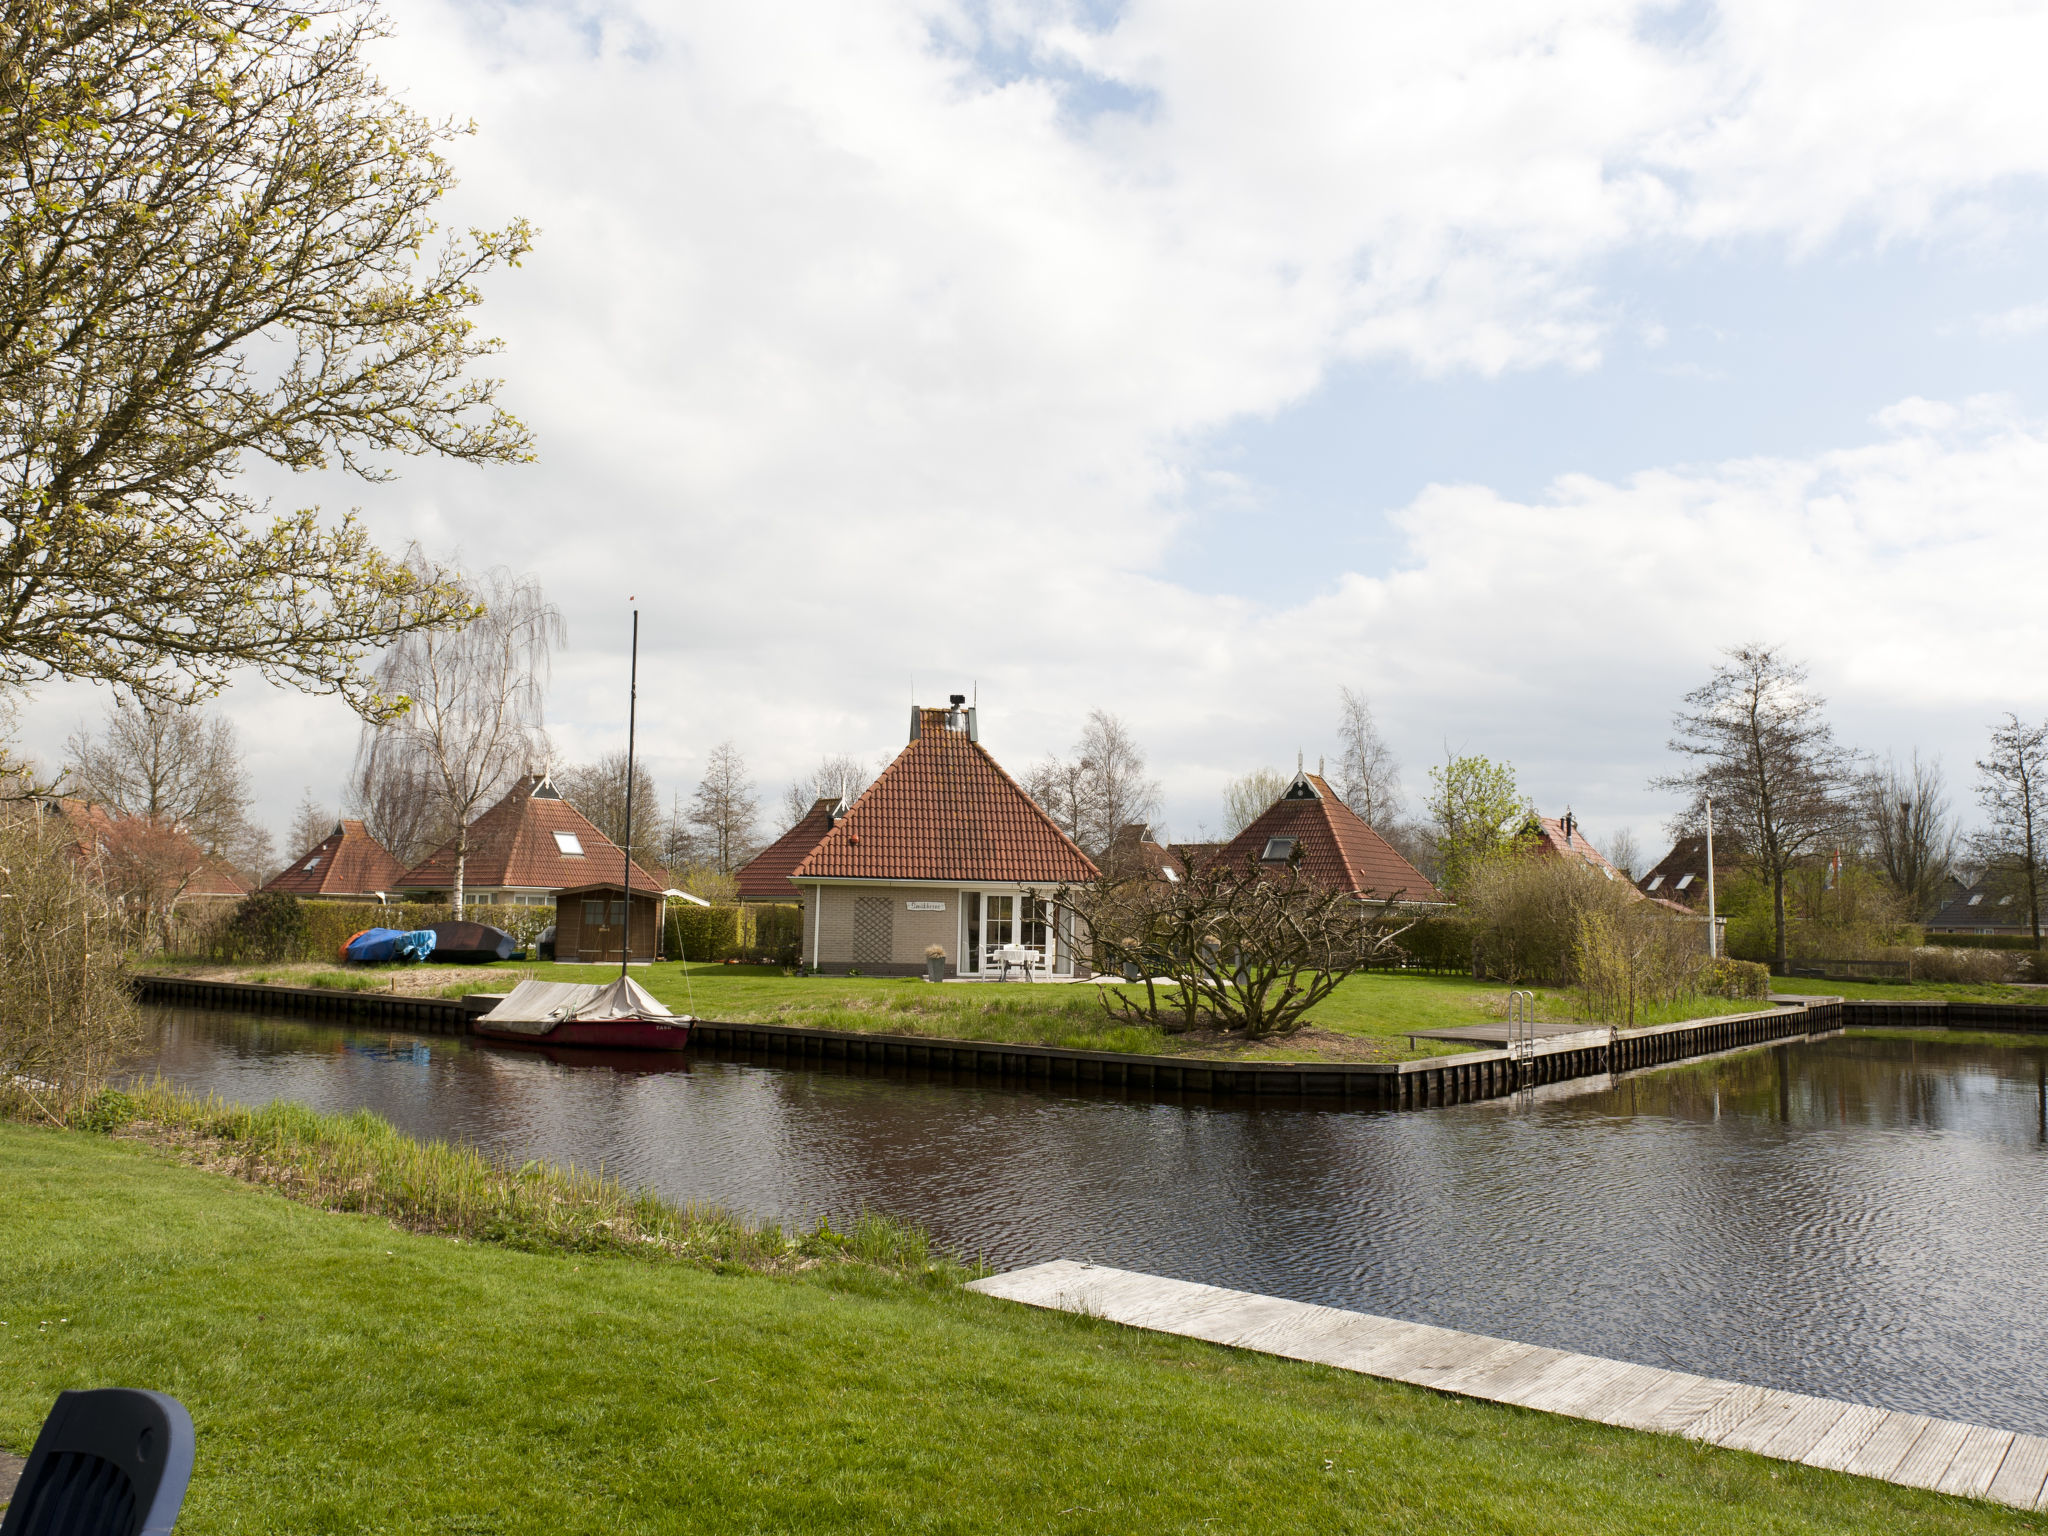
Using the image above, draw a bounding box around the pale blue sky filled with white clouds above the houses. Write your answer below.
[25,0,2048,852]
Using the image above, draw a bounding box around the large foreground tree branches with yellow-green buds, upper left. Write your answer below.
[0,0,530,719]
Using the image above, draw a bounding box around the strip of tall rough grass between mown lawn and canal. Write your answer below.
[72,1079,975,1284]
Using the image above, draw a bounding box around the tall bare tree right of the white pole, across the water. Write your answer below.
[1651,643,1855,971]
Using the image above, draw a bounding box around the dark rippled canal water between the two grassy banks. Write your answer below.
[137,1010,2048,1434]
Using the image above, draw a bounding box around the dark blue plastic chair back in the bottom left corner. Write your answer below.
[0,1386,195,1536]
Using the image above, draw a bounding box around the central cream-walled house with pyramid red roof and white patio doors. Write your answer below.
[784,700,1096,977]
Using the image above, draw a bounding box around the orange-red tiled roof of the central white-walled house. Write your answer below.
[791,709,1096,887]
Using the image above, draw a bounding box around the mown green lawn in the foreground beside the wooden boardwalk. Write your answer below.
[0,1124,2042,1536]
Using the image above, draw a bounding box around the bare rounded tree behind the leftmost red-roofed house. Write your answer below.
[66,694,274,885]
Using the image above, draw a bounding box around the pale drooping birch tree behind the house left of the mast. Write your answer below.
[350,549,563,911]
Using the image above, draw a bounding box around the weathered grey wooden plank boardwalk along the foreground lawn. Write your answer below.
[969,1260,2048,1509]
